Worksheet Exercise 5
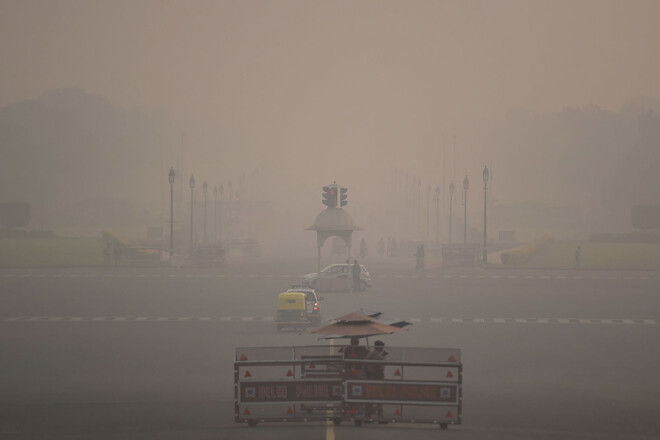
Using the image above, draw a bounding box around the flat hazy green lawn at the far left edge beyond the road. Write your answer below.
[0,237,103,267]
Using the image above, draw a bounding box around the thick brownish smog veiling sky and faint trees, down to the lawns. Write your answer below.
[0,0,660,251]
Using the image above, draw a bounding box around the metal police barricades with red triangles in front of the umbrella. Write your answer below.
[234,345,463,429]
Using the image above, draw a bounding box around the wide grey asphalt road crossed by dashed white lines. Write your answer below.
[0,260,660,439]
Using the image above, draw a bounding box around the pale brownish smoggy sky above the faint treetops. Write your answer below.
[0,0,660,218]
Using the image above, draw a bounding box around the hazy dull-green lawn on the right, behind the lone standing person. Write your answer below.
[517,241,660,270]
